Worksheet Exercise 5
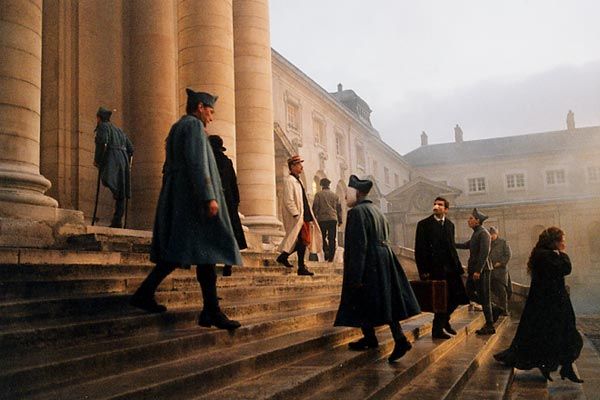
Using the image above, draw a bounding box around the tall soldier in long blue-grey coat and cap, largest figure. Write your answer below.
[131,89,242,329]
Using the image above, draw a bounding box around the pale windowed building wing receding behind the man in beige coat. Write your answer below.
[272,51,411,236]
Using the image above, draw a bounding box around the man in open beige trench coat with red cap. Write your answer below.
[277,155,322,276]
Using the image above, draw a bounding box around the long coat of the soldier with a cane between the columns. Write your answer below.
[94,121,133,199]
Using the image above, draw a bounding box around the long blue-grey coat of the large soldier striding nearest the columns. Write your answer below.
[150,115,242,266]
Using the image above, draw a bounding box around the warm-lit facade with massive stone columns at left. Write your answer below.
[0,0,281,245]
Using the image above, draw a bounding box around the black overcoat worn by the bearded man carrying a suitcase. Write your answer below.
[415,215,469,309]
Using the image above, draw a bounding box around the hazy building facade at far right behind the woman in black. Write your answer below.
[387,127,600,279]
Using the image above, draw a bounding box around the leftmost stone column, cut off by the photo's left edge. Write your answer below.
[0,0,58,211]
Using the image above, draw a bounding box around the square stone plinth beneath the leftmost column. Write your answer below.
[0,200,85,248]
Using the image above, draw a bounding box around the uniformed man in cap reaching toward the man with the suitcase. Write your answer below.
[456,208,496,335]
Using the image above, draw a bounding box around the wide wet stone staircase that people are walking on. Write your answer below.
[0,237,600,399]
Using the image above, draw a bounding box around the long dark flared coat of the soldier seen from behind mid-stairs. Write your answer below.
[334,200,421,327]
